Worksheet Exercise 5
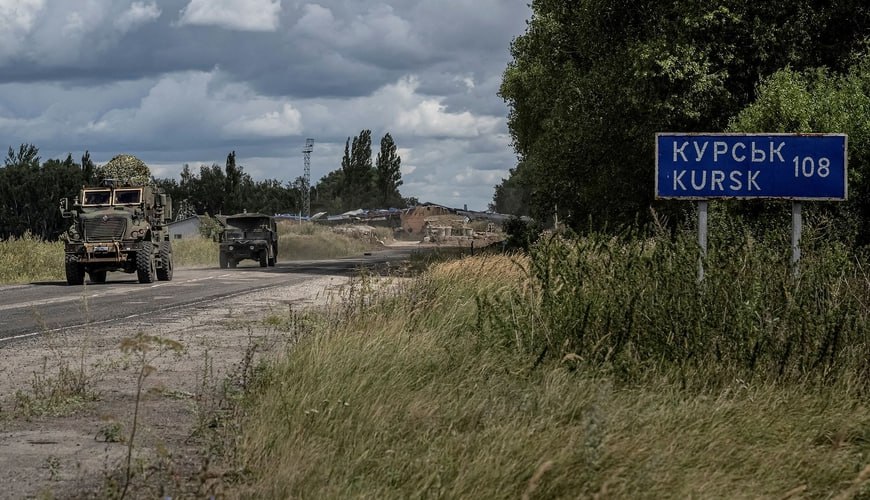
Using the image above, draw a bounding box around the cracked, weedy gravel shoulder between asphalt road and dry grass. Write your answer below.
[0,276,347,498]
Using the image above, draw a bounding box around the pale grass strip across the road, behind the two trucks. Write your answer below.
[0,223,390,284]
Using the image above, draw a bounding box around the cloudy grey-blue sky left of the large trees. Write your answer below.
[0,0,530,210]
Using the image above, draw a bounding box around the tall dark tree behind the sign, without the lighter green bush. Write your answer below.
[500,0,870,229]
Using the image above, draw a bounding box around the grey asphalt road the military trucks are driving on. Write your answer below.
[0,248,414,349]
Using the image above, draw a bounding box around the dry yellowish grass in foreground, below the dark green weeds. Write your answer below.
[236,252,870,498]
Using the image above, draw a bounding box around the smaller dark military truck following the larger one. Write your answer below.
[218,213,278,269]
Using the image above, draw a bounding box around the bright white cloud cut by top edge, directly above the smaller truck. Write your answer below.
[179,0,281,31]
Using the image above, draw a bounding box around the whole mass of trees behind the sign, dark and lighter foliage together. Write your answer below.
[493,0,870,243]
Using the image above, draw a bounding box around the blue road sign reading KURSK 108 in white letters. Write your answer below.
[656,133,848,200]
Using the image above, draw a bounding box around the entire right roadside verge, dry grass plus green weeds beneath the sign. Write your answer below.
[227,229,870,498]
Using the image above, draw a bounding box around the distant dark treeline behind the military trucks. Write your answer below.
[0,130,416,239]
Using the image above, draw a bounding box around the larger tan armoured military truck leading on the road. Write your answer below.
[60,179,172,285]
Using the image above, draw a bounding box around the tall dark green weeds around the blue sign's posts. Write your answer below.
[480,226,870,390]
